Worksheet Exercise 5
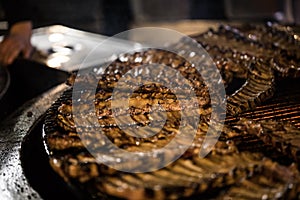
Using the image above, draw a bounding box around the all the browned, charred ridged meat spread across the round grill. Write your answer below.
[44,24,300,199]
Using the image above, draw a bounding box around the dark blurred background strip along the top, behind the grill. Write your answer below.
[0,0,300,35]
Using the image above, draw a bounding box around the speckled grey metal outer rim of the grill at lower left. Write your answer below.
[0,84,67,200]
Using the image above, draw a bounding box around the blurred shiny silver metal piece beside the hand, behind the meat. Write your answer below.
[31,25,139,72]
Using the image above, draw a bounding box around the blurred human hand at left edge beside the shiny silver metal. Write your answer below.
[0,21,33,65]
